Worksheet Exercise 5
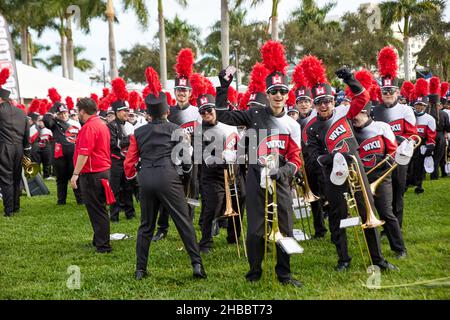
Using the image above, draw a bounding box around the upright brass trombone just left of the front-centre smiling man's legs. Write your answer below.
[222,164,247,258]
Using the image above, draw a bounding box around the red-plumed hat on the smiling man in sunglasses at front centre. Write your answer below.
[261,40,289,92]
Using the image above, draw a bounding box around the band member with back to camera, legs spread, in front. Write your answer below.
[124,67,206,280]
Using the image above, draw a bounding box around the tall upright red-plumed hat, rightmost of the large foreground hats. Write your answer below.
[378,46,398,88]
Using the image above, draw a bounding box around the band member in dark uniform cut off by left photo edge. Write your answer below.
[0,68,31,217]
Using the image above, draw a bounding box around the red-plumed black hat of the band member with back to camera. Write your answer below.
[145,67,169,118]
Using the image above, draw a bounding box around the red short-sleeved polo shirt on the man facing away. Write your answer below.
[73,115,111,173]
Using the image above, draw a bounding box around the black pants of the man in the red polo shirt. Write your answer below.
[79,170,111,252]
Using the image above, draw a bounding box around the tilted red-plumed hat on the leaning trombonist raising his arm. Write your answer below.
[300,55,334,103]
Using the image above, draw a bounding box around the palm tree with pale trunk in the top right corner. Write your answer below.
[380,0,444,80]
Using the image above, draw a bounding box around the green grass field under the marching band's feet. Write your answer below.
[0,178,450,300]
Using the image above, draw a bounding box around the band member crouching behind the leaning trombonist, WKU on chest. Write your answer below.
[352,70,407,259]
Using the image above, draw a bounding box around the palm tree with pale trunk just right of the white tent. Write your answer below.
[105,0,149,79]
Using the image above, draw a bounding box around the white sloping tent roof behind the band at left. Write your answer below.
[16,61,102,100]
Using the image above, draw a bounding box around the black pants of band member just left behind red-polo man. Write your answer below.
[54,152,83,204]
